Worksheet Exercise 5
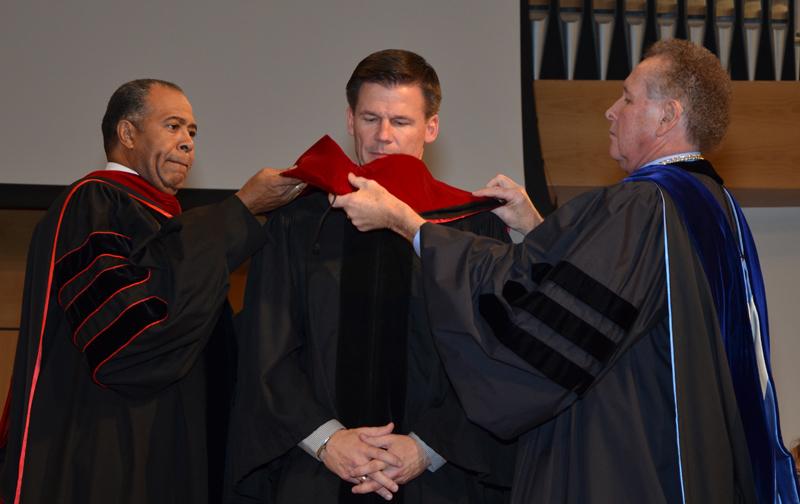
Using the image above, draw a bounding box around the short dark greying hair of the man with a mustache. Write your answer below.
[100,79,183,156]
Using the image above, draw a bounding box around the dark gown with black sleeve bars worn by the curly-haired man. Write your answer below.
[421,177,755,504]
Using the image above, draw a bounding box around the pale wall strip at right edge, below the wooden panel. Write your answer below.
[744,208,800,446]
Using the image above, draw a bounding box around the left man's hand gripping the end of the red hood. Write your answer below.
[236,168,306,215]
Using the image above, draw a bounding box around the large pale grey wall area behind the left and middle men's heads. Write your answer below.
[0,0,522,192]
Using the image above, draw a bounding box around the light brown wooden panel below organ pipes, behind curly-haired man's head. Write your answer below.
[534,80,800,206]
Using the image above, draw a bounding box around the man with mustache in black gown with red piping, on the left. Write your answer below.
[0,79,303,504]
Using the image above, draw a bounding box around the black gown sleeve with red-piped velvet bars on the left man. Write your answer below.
[52,182,263,395]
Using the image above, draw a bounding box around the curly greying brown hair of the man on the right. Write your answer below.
[644,39,731,150]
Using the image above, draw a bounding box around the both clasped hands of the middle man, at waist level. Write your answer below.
[322,422,429,500]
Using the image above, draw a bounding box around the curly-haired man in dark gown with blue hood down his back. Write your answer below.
[335,40,798,504]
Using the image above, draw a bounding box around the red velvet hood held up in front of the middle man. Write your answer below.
[283,135,500,217]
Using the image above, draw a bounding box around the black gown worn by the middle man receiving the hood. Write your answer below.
[228,193,514,503]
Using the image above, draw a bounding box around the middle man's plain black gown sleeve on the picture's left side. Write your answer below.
[228,205,334,488]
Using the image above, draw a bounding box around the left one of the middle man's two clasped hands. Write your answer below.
[320,422,403,500]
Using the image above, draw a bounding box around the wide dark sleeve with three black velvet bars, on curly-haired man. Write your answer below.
[421,184,663,438]
